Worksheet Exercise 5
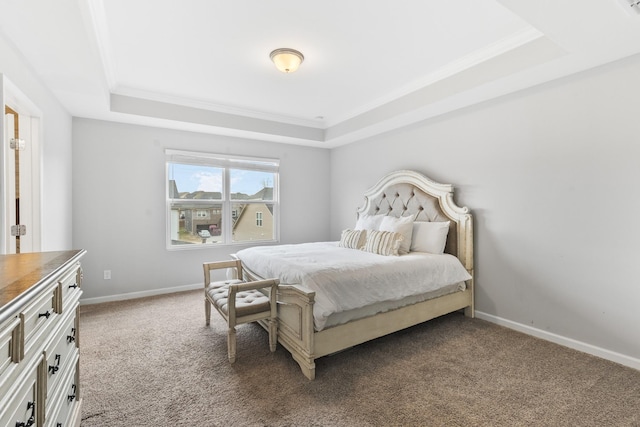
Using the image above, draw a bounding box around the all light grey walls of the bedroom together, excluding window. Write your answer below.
[8,15,640,366]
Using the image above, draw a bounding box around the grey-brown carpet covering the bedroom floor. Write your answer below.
[80,291,640,427]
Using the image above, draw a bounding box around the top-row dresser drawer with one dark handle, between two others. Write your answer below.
[20,283,58,357]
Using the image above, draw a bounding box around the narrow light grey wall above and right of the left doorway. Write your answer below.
[0,34,72,251]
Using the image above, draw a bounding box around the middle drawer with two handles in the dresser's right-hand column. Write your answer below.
[44,310,78,396]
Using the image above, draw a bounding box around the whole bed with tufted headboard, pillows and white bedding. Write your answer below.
[233,170,474,380]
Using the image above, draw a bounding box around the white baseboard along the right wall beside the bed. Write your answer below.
[475,310,640,371]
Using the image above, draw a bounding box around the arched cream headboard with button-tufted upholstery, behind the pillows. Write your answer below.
[357,170,473,275]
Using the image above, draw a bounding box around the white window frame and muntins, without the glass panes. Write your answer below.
[165,148,280,251]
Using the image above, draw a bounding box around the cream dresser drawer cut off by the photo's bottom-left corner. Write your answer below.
[0,369,40,427]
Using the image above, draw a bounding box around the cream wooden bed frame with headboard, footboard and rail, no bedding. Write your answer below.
[238,170,474,380]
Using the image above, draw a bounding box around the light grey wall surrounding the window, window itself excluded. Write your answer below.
[73,118,330,302]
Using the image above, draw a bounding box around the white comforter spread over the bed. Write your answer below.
[237,242,471,330]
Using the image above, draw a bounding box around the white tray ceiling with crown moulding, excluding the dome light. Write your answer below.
[0,0,640,147]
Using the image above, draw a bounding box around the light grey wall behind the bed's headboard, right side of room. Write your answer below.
[331,56,640,369]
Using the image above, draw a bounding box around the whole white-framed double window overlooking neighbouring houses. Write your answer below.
[166,150,279,249]
